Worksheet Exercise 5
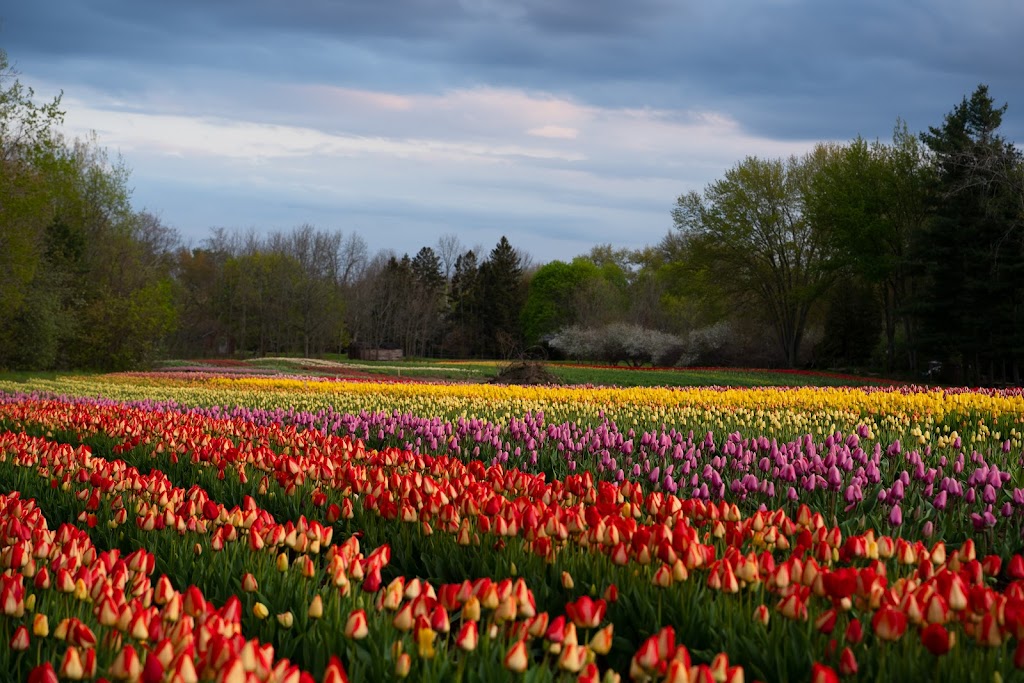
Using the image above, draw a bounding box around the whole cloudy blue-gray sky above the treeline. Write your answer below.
[0,0,1024,262]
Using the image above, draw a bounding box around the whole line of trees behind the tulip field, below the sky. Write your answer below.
[0,46,1024,384]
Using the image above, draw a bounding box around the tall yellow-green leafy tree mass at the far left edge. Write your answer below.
[0,53,175,369]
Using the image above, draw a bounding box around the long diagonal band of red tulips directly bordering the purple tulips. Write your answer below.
[6,389,1020,675]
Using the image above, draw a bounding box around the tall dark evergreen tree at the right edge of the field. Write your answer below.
[916,85,1024,383]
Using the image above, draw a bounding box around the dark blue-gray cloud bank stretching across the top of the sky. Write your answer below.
[0,0,1024,137]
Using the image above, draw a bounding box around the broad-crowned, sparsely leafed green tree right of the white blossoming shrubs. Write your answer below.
[673,153,836,367]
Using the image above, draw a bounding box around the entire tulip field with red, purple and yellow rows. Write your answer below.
[0,370,1024,683]
